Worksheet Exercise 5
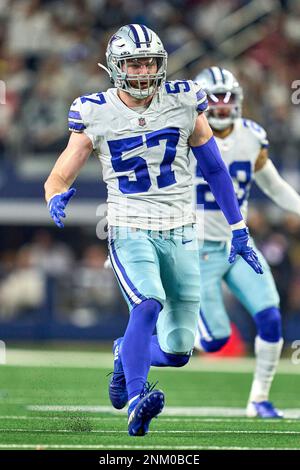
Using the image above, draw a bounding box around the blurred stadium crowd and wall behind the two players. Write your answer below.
[0,0,300,349]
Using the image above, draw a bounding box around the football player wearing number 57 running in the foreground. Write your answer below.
[45,24,261,436]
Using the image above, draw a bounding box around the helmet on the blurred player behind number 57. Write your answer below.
[195,66,243,130]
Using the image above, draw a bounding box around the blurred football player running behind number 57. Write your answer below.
[194,67,300,418]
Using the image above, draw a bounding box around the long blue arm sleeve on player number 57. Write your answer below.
[191,136,243,225]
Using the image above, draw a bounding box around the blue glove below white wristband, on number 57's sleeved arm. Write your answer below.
[228,228,263,274]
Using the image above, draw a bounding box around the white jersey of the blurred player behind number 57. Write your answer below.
[192,118,268,241]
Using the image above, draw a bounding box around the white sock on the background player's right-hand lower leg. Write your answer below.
[249,336,283,402]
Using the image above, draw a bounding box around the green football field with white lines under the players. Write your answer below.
[0,350,300,450]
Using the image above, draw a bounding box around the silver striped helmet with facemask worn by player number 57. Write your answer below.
[98,24,168,99]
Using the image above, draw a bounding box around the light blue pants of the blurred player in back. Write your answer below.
[198,241,279,341]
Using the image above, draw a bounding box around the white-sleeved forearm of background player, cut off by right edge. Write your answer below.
[255,160,300,216]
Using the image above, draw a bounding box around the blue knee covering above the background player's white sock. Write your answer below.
[254,307,282,343]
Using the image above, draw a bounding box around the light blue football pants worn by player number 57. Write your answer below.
[109,225,200,354]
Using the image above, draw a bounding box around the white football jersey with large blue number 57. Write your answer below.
[69,80,207,230]
